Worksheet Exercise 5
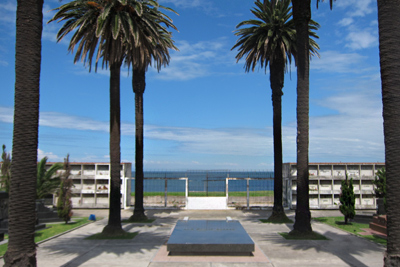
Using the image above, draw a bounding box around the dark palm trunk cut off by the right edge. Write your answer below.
[378,0,400,266]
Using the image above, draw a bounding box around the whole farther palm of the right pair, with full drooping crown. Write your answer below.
[232,0,319,221]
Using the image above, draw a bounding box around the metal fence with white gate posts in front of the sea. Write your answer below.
[126,170,280,209]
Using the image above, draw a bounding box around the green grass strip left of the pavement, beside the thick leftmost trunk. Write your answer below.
[0,218,89,256]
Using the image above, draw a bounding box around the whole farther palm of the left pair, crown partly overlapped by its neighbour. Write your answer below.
[125,1,178,221]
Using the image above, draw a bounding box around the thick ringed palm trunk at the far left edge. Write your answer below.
[4,0,43,266]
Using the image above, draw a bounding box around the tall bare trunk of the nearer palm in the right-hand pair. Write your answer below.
[292,0,312,232]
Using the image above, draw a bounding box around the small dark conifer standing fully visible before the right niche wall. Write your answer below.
[339,173,356,224]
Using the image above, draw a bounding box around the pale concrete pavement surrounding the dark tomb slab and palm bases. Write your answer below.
[1,210,385,267]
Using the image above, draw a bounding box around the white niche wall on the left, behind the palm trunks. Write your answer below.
[46,162,132,208]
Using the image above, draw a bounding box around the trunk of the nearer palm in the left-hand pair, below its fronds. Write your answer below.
[103,62,125,236]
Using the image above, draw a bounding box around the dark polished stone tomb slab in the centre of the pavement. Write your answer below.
[167,220,255,256]
